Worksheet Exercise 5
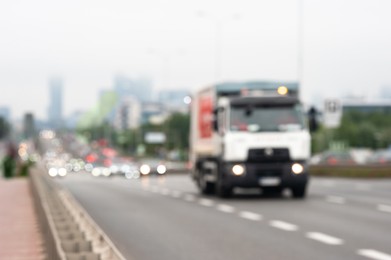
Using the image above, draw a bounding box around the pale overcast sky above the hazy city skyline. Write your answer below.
[0,0,391,119]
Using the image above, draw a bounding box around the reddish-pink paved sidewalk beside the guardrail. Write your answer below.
[0,176,44,260]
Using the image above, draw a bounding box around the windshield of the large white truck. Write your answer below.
[230,104,304,132]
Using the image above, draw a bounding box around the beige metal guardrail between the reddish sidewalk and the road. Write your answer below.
[30,165,125,260]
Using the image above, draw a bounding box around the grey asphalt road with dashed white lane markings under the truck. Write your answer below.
[58,174,391,260]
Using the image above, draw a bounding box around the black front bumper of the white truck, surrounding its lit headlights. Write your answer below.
[221,162,309,188]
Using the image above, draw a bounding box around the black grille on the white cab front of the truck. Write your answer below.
[247,148,290,162]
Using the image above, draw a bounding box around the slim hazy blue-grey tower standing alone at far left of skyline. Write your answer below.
[48,78,63,129]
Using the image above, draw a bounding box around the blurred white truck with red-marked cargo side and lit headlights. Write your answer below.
[190,82,310,198]
